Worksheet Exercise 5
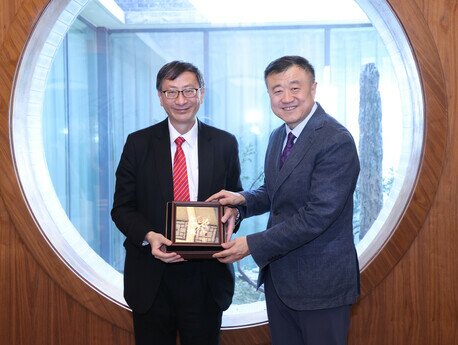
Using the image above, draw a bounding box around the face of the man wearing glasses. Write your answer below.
[157,72,204,130]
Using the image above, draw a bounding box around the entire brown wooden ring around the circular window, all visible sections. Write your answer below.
[0,0,448,344]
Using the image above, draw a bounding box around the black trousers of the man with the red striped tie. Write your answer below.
[133,262,222,345]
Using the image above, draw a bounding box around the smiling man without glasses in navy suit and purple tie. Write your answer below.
[208,56,359,345]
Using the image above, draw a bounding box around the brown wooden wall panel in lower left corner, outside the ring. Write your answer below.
[0,188,133,345]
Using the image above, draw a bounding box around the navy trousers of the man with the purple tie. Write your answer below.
[264,270,351,345]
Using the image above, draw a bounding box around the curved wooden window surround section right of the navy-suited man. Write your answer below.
[361,0,448,298]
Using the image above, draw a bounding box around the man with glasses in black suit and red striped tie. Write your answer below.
[111,61,242,345]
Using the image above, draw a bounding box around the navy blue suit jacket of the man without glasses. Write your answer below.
[243,105,359,310]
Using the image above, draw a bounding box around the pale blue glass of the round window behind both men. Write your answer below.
[43,0,412,320]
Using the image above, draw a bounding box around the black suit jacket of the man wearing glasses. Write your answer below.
[111,119,242,313]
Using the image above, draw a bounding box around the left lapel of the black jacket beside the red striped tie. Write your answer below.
[152,119,173,201]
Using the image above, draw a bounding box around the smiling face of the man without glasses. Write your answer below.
[266,66,316,129]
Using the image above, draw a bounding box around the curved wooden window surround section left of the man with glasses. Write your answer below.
[0,0,131,331]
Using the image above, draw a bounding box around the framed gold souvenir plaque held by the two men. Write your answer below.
[166,201,226,260]
